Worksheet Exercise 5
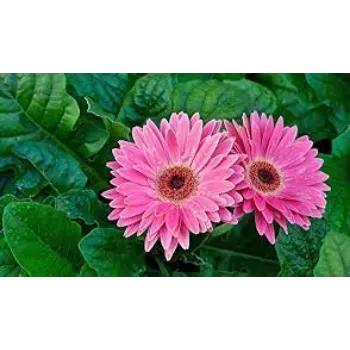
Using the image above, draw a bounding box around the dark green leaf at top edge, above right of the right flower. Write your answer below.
[253,72,337,141]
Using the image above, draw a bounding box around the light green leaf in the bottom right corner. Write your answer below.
[314,232,350,279]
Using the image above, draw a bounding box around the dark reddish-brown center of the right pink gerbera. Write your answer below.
[248,160,282,194]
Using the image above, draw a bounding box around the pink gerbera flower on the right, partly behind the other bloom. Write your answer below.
[225,112,330,244]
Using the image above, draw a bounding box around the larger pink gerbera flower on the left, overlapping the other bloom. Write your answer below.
[103,113,244,260]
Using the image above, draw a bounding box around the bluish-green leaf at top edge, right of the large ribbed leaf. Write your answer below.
[65,72,129,115]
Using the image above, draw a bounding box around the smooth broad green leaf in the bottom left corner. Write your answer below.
[3,203,82,278]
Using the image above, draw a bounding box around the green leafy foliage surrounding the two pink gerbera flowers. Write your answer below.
[0,72,350,279]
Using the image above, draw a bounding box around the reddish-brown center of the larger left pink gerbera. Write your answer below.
[157,165,198,202]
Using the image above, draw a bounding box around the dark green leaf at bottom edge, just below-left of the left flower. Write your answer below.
[79,229,145,278]
